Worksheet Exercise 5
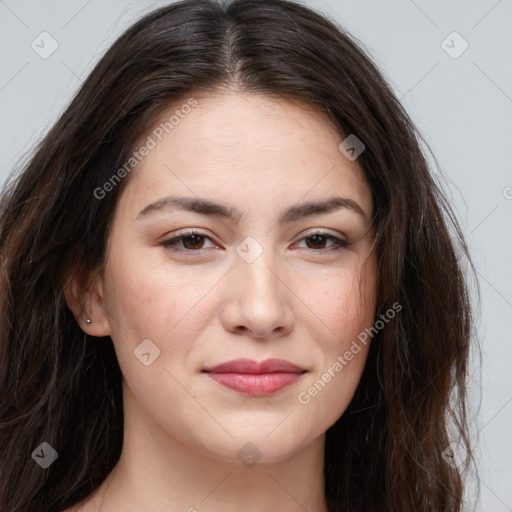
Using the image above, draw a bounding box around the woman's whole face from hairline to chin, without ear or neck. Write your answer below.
[95,92,376,462]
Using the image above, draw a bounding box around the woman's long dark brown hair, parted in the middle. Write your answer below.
[0,0,480,512]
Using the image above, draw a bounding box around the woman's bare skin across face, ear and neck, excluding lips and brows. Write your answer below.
[66,89,377,512]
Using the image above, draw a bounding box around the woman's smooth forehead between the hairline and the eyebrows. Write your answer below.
[119,91,372,216]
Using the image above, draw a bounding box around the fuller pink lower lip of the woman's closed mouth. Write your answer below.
[208,372,302,396]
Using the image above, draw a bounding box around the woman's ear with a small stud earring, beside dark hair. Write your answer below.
[63,262,110,336]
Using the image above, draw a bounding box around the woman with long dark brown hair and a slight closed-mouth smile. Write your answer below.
[0,0,472,512]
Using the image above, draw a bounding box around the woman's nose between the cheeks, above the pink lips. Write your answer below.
[221,244,297,339]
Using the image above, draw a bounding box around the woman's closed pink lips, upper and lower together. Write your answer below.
[203,359,306,396]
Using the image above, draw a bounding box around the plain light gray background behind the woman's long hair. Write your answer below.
[0,0,512,512]
